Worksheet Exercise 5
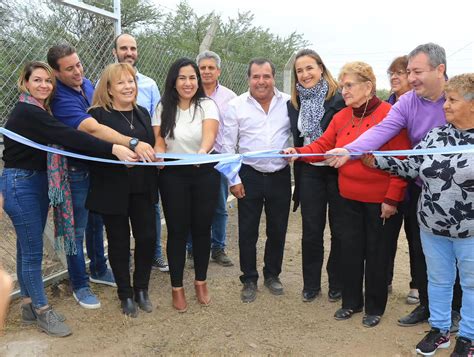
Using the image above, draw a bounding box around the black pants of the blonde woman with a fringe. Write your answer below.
[102,194,156,300]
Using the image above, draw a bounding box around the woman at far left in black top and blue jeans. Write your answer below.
[2,61,135,337]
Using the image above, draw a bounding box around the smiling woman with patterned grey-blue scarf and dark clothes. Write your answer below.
[288,49,345,302]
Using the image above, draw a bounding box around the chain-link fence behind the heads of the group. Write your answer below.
[0,0,283,126]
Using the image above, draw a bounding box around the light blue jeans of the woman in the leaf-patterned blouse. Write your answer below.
[420,229,474,340]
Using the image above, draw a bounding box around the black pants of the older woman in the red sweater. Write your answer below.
[342,198,401,315]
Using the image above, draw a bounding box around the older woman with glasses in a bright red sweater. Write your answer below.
[285,62,410,327]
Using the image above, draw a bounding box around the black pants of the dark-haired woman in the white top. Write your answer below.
[159,164,220,288]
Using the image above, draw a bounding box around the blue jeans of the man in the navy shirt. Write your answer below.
[66,167,107,291]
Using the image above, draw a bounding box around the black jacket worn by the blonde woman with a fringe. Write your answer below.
[86,107,158,215]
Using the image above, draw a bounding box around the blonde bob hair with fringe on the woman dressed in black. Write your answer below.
[91,63,138,111]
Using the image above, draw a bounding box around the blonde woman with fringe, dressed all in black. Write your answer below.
[86,63,158,317]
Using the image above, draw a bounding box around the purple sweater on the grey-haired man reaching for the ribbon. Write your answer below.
[344,90,446,152]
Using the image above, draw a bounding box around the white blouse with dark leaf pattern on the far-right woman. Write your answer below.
[375,124,474,238]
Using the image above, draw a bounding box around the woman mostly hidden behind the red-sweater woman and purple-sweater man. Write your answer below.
[387,56,420,305]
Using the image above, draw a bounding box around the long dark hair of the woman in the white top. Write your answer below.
[161,57,206,139]
